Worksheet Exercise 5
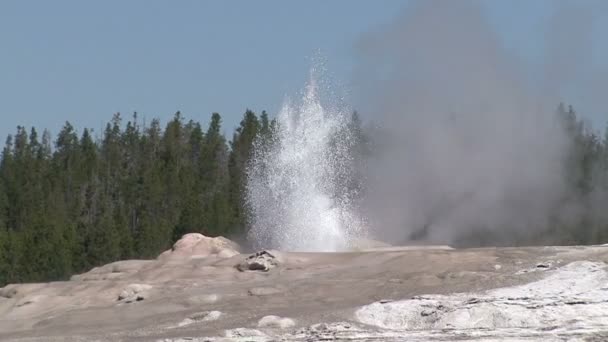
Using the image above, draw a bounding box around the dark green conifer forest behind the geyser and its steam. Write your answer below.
[0,105,608,286]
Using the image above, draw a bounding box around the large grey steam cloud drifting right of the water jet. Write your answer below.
[355,1,591,243]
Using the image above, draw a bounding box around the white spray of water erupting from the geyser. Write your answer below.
[246,68,362,251]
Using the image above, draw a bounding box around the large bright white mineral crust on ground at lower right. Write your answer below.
[355,261,608,330]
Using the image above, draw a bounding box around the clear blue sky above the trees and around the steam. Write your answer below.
[0,0,608,139]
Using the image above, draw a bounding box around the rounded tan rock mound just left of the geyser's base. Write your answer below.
[158,233,240,261]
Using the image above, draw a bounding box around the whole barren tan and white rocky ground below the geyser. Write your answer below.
[0,234,608,342]
